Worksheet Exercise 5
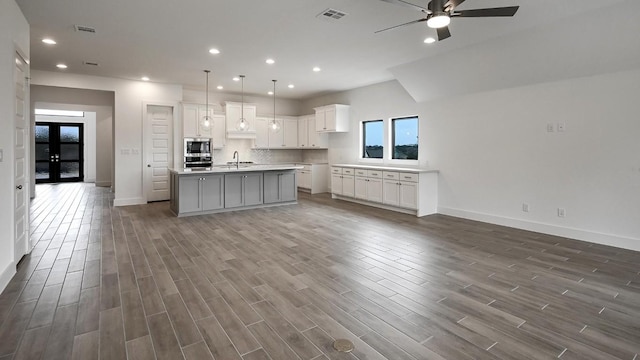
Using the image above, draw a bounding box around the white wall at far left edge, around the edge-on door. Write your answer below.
[0,0,29,292]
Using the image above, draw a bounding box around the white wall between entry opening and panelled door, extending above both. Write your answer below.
[31,71,182,206]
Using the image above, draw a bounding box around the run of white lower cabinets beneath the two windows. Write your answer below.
[331,165,438,216]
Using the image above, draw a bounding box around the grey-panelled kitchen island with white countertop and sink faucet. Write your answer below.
[169,164,303,216]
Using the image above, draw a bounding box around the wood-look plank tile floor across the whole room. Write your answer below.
[0,184,640,360]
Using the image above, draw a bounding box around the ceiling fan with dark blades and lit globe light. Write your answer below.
[375,0,519,41]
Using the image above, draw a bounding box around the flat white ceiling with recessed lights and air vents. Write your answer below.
[17,0,624,99]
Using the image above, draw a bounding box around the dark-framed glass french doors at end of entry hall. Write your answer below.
[35,122,84,183]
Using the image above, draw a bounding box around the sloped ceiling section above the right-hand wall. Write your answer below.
[390,0,640,102]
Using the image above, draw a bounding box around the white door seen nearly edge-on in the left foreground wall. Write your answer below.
[14,53,30,263]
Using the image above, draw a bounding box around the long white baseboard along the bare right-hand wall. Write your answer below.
[438,207,640,251]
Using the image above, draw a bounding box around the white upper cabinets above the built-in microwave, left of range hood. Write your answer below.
[182,104,226,149]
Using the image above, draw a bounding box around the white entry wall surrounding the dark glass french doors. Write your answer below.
[32,112,96,183]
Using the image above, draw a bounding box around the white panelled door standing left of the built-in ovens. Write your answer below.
[144,105,173,202]
